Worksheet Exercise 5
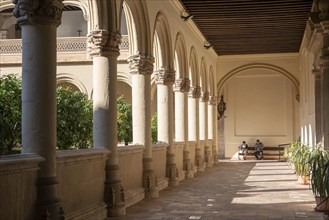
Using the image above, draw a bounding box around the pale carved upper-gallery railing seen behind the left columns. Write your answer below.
[0,35,129,55]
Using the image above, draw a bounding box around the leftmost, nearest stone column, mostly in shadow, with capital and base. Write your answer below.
[13,0,64,219]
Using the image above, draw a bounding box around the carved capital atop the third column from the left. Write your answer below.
[127,54,154,75]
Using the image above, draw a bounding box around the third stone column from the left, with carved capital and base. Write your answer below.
[128,54,159,198]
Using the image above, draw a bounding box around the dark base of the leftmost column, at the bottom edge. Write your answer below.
[34,177,64,220]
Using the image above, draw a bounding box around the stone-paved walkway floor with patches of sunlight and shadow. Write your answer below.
[110,160,325,220]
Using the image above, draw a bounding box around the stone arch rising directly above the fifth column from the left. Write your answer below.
[174,33,188,78]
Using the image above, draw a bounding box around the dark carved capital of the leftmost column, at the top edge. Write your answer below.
[12,0,64,26]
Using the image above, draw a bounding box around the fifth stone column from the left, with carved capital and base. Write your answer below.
[174,78,194,178]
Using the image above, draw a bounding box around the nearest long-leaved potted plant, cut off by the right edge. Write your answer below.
[309,145,329,211]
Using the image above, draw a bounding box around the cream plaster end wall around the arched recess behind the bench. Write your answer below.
[217,54,299,157]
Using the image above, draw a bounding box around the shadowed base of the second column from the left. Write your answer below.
[104,165,126,217]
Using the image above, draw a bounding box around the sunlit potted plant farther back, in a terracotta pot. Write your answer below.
[288,142,311,184]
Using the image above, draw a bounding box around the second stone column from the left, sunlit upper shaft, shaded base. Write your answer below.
[88,30,126,216]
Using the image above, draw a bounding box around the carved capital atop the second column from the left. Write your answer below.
[87,30,121,57]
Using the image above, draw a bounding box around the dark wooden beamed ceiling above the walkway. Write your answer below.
[181,0,313,55]
